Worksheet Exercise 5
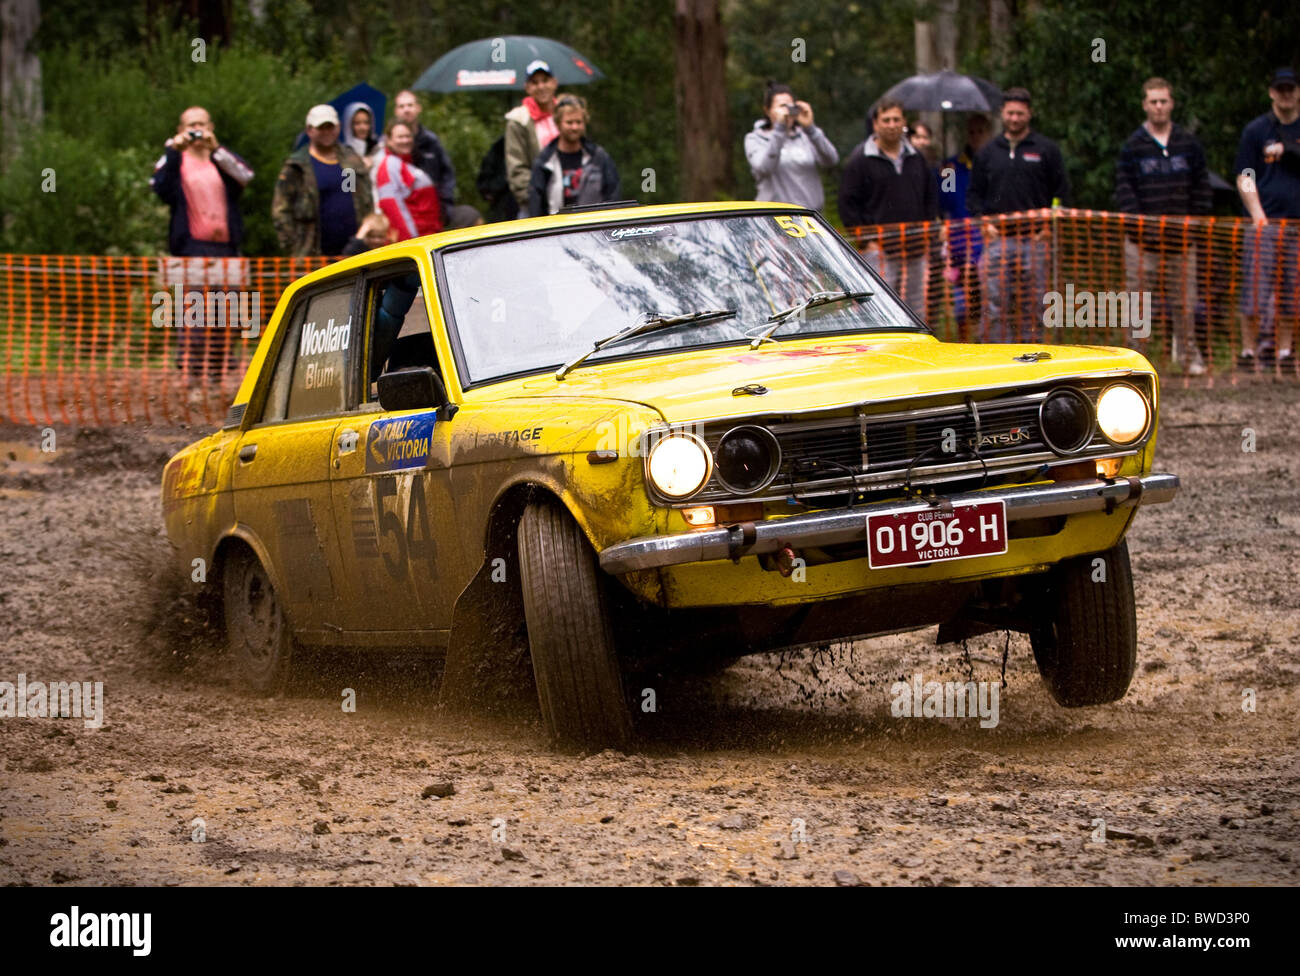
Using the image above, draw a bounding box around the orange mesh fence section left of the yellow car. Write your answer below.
[0,255,326,426]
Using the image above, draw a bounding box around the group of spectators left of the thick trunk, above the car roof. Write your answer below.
[152,60,621,267]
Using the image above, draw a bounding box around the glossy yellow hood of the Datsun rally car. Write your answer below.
[507,335,1154,424]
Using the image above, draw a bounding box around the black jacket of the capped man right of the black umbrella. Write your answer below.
[966,130,1070,230]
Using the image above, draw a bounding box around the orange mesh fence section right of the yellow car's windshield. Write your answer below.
[848,208,1300,383]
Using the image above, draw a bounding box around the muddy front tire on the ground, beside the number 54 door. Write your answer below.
[519,502,632,749]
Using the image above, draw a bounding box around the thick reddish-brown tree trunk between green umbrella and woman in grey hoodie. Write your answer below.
[672,0,733,200]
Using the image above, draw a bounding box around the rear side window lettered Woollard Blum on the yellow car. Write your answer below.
[283,279,358,420]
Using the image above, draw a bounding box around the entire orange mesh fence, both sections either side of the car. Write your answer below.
[0,217,1300,426]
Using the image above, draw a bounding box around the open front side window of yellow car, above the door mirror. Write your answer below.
[365,261,442,400]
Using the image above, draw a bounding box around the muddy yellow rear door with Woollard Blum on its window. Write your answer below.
[233,274,359,639]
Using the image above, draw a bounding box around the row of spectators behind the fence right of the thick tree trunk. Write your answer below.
[745,68,1300,376]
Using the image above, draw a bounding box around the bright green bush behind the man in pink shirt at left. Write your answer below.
[0,32,341,255]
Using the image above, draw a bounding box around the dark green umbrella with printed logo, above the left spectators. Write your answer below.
[411,34,605,91]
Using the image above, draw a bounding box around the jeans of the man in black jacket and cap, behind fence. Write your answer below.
[980,234,1050,342]
